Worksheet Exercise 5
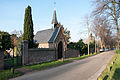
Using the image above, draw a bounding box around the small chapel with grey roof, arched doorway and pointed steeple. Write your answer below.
[34,9,67,59]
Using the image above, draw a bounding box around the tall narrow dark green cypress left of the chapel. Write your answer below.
[23,6,34,48]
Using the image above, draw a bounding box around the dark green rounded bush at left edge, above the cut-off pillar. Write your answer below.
[0,31,12,51]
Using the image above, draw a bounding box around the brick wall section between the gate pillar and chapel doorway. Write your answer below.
[28,48,55,64]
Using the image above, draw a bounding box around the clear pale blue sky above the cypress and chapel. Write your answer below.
[0,0,93,42]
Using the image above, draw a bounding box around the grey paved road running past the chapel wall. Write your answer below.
[11,51,115,80]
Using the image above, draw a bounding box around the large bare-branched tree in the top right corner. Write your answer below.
[93,0,120,35]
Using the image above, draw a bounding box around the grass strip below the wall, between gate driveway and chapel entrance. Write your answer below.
[23,60,72,70]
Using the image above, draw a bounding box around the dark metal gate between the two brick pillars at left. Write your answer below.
[4,45,22,69]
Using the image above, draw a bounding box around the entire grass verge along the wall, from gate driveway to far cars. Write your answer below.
[23,53,98,70]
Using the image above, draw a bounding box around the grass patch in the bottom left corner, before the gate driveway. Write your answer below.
[0,69,21,80]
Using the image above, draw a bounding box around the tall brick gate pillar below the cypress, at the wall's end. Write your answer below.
[21,40,28,65]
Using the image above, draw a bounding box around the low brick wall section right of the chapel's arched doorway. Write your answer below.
[65,49,80,58]
